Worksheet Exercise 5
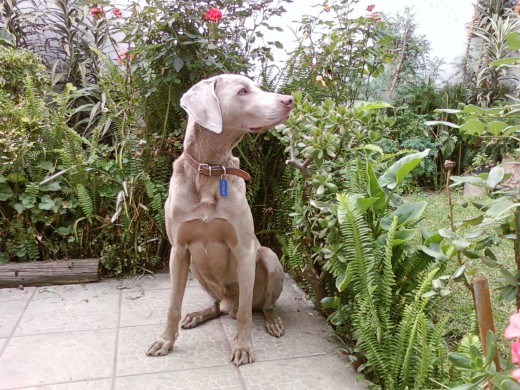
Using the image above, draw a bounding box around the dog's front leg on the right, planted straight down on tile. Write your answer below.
[231,243,256,367]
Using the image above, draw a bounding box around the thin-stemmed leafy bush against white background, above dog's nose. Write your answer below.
[285,0,393,106]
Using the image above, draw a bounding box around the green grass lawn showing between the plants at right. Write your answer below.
[406,192,515,352]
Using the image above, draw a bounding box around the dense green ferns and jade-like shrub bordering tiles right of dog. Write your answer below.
[278,94,445,389]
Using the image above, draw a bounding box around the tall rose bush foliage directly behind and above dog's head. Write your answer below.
[124,0,285,137]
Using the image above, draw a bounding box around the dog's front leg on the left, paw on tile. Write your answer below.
[146,247,190,356]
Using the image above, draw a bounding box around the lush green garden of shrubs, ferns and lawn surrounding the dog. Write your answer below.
[0,0,520,389]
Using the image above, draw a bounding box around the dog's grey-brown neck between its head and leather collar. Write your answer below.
[184,118,244,165]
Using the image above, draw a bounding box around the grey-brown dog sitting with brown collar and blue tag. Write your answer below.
[146,74,293,366]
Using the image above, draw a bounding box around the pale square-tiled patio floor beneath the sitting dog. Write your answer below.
[0,274,366,390]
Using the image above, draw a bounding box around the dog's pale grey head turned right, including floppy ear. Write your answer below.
[181,74,293,133]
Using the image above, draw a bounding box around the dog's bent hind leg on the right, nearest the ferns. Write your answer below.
[257,247,285,337]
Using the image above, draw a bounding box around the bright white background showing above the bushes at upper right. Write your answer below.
[270,0,474,79]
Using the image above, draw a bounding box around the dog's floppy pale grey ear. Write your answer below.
[181,77,222,134]
